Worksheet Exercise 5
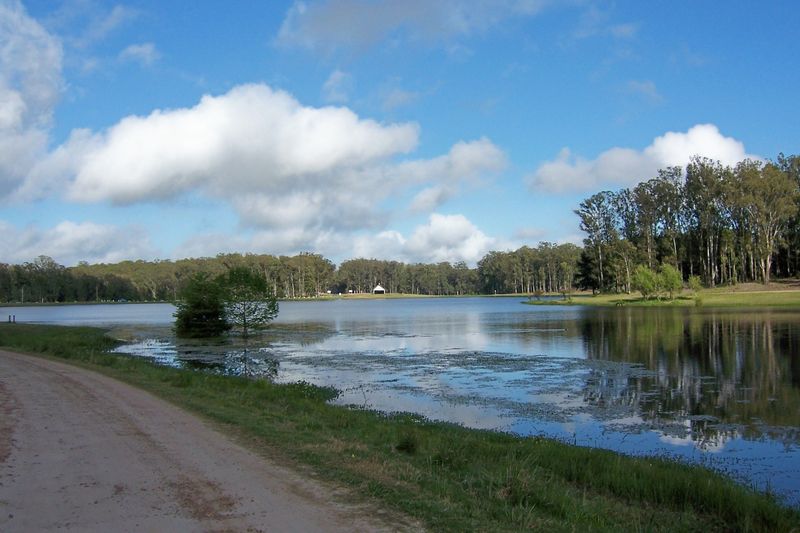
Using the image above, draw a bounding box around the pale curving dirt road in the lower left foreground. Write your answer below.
[0,351,410,532]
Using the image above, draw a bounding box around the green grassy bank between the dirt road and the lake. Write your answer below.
[0,324,800,531]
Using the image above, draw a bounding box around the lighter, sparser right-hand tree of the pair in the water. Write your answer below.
[217,267,278,338]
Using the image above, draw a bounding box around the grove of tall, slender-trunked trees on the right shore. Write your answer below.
[575,154,800,292]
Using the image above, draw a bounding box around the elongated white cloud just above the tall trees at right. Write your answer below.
[526,124,758,193]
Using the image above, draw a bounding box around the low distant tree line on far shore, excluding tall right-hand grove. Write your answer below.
[0,242,580,303]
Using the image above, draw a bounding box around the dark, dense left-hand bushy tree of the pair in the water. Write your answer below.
[175,273,230,338]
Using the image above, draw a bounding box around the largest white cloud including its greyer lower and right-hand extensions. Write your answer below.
[23,84,506,253]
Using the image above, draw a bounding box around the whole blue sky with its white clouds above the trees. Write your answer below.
[0,0,800,265]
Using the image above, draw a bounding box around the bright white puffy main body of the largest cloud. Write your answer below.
[47,85,418,204]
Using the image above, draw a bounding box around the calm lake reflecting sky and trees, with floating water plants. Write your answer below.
[0,298,800,506]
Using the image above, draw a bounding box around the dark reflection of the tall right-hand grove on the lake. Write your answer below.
[581,308,800,444]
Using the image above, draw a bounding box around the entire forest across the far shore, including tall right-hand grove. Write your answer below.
[0,154,800,303]
